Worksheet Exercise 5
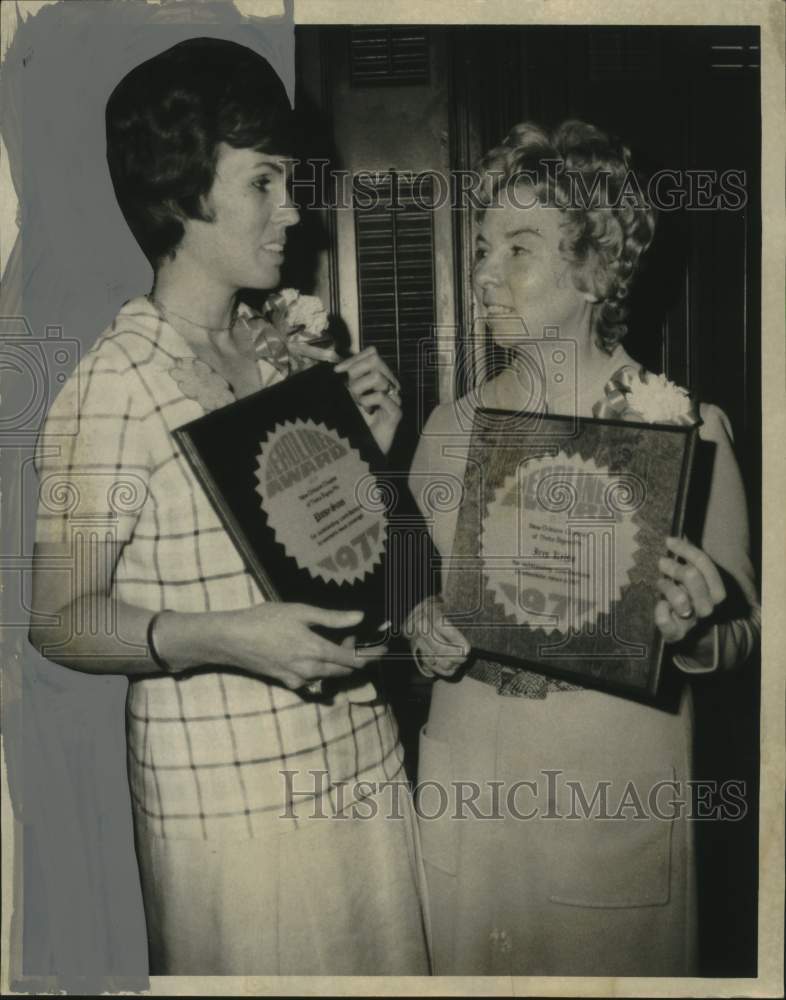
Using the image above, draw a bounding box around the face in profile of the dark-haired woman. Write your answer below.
[177,143,300,292]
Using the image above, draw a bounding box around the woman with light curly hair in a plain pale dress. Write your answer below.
[412,121,759,976]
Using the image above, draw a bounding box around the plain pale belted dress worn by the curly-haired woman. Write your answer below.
[411,362,758,976]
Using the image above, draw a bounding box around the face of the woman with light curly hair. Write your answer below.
[472,184,590,347]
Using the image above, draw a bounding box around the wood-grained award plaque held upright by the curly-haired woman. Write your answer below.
[444,410,696,700]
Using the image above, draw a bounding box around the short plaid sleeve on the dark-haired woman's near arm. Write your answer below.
[35,354,150,544]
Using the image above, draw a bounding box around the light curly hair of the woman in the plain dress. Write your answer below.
[480,121,655,354]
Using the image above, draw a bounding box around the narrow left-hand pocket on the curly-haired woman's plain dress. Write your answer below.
[415,726,459,875]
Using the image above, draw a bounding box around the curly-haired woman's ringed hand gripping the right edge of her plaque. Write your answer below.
[655,538,726,642]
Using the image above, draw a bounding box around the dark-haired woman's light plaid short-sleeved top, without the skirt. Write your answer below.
[36,298,404,838]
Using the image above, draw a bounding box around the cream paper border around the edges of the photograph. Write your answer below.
[0,0,786,997]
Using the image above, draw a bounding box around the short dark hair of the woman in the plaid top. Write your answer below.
[106,38,295,267]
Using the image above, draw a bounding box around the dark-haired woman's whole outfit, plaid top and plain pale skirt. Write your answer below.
[37,298,428,975]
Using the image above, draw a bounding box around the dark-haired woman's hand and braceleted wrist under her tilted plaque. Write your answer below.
[156,601,386,690]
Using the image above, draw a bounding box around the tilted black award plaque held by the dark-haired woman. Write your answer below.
[174,364,431,641]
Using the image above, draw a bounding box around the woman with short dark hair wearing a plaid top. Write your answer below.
[30,38,428,975]
